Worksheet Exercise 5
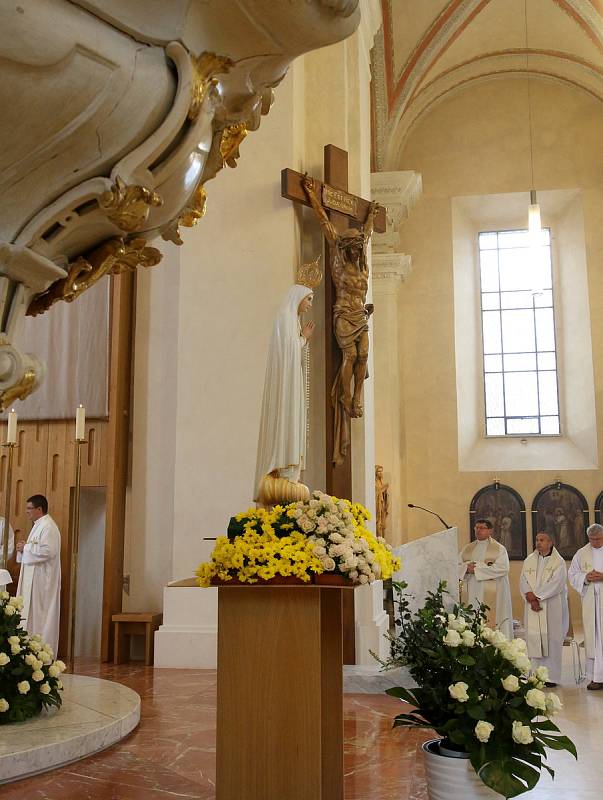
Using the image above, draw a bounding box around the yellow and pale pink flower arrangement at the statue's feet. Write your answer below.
[196,492,400,586]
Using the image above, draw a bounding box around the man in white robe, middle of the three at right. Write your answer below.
[519,532,569,686]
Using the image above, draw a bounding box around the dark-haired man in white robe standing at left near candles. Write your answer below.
[17,494,61,656]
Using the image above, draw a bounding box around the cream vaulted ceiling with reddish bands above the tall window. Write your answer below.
[373,0,603,169]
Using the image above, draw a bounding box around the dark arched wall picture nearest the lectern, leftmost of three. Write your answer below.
[469,481,526,561]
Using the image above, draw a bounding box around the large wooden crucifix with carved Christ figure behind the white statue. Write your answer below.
[281,144,386,500]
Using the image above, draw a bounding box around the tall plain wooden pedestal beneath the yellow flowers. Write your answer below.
[216,584,353,800]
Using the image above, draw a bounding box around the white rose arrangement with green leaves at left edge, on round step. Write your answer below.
[0,592,65,725]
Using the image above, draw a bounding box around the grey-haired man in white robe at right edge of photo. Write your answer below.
[568,523,603,689]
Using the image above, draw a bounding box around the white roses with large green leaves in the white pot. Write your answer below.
[381,583,577,798]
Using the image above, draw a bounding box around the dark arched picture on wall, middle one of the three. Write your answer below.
[532,481,589,560]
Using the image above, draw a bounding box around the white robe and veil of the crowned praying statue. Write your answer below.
[253,283,312,500]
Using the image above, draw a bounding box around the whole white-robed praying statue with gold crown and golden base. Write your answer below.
[253,259,322,506]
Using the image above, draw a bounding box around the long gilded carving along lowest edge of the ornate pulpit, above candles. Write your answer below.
[27,238,161,317]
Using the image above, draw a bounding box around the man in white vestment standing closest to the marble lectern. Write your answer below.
[459,519,513,639]
